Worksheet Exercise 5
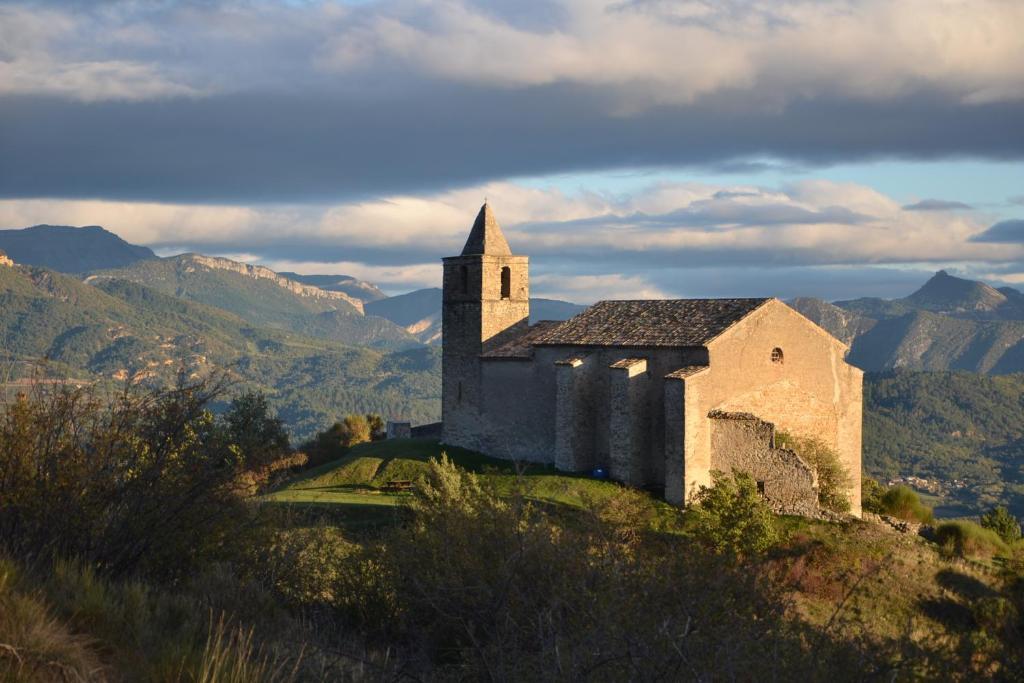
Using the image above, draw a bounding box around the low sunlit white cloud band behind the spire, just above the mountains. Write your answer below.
[0,180,1024,296]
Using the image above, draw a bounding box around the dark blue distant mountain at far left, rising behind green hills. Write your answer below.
[0,225,157,273]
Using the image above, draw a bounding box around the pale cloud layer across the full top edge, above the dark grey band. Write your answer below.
[0,0,1024,105]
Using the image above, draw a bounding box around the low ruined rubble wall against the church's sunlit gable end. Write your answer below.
[708,412,818,516]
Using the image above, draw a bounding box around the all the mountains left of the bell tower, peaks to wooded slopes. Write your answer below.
[0,225,582,438]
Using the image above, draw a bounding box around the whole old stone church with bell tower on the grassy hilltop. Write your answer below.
[441,204,863,515]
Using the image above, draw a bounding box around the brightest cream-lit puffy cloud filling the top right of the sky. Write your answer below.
[325,0,1024,103]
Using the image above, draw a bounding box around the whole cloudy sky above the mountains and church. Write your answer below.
[0,0,1024,302]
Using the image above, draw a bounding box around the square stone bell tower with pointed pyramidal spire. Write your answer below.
[441,203,529,449]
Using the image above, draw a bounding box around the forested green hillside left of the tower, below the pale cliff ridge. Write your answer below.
[0,266,440,438]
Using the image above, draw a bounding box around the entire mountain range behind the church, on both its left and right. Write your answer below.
[0,226,1024,514]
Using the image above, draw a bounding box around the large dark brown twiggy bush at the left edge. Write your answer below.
[0,380,280,579]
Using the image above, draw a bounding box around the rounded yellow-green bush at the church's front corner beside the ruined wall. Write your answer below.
[691,472,779,556]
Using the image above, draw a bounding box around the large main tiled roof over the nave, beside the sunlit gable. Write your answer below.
[532,299,768,347]
